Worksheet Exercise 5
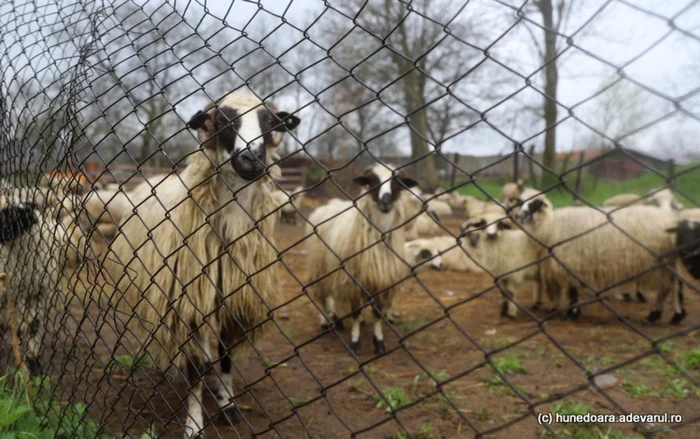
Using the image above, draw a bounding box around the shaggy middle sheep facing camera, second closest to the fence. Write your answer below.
[306,165,417,355]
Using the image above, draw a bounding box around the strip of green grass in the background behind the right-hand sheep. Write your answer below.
[458,163,700,207]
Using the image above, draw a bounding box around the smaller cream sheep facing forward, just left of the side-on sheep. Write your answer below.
[464,214,541,319]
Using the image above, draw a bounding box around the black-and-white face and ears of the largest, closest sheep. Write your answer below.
[187,92,301,181]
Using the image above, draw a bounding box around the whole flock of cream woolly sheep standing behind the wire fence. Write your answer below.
[0,91,700,437]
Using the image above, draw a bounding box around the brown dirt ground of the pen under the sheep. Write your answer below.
[17,215,700,439]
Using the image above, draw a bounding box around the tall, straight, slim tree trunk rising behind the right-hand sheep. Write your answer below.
[537,0,564,189]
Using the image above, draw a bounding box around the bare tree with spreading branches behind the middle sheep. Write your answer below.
[326,0,490,188]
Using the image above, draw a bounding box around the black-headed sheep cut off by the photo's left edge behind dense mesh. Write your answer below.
[0,203,64,376]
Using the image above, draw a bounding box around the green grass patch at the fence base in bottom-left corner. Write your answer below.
[0,372,106,439]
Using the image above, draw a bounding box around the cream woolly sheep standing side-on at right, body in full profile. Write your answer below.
[518,199,685,323]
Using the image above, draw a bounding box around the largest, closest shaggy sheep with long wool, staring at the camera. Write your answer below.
[103,91,300,437]
